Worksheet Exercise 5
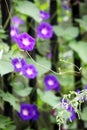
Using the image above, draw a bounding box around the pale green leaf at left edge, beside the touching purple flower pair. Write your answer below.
[0,60,14,76]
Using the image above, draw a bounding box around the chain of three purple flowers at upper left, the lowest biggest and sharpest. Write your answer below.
[10,16,36,51]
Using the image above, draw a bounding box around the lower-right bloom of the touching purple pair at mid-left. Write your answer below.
[23,64,38,79]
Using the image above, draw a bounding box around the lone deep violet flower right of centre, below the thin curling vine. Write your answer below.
[44,75,60,91]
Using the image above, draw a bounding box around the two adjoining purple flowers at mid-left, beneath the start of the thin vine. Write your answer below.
[12,58,38,79]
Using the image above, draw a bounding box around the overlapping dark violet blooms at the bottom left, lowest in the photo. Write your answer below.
[18,103,40,121]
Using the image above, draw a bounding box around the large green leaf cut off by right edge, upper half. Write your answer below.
[69,41,87,63]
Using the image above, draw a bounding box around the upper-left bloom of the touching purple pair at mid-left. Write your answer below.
[12,58,26,72]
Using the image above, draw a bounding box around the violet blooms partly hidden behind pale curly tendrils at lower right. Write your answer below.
[60,100,76,121]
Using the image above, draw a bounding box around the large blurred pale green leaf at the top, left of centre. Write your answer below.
[17,1,40,22]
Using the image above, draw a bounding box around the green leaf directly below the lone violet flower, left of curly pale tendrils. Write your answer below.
[37,89,60,107]
